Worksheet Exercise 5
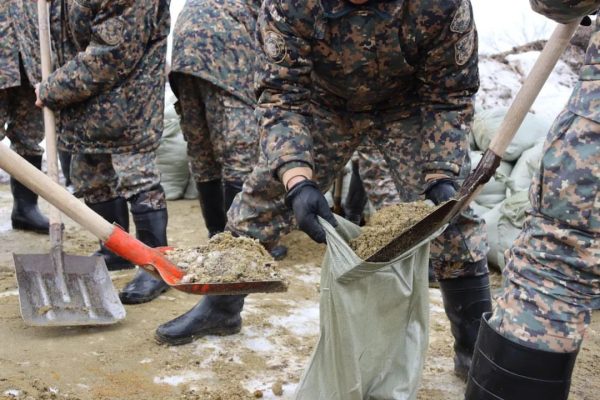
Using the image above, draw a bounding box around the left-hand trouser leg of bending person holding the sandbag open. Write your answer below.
[227,107,365,246]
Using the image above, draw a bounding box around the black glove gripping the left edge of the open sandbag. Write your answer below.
[285,179,337,243]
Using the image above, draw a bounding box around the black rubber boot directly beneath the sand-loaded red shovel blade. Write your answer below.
[155,295,245,346]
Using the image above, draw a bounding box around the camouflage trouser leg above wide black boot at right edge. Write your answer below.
[490,111,600,352]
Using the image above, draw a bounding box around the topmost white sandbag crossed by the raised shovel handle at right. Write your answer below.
[473,107,553,161]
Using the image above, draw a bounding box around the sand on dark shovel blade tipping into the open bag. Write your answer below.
[350,201,433,260]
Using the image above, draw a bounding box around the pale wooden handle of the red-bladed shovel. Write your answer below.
[0,143,114,241]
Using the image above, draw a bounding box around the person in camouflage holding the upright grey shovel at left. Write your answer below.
[38,0,170,303]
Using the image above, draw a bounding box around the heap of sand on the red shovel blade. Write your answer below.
[165,232,281,283]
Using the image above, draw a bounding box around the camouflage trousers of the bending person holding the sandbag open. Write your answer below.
[228,107,488,279]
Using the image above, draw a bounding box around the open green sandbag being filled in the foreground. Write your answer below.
[295,216,429,400]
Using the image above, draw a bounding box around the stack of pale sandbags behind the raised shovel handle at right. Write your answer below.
[469,107,553,269]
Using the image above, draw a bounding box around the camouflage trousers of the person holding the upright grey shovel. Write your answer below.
[71,151,167,212]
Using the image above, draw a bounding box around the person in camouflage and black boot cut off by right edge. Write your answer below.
[466,0,600,400]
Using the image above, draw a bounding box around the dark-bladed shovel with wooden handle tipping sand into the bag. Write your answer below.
[367,21,579,262]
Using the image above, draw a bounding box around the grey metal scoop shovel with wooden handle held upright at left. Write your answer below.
[14,0,125,326]
